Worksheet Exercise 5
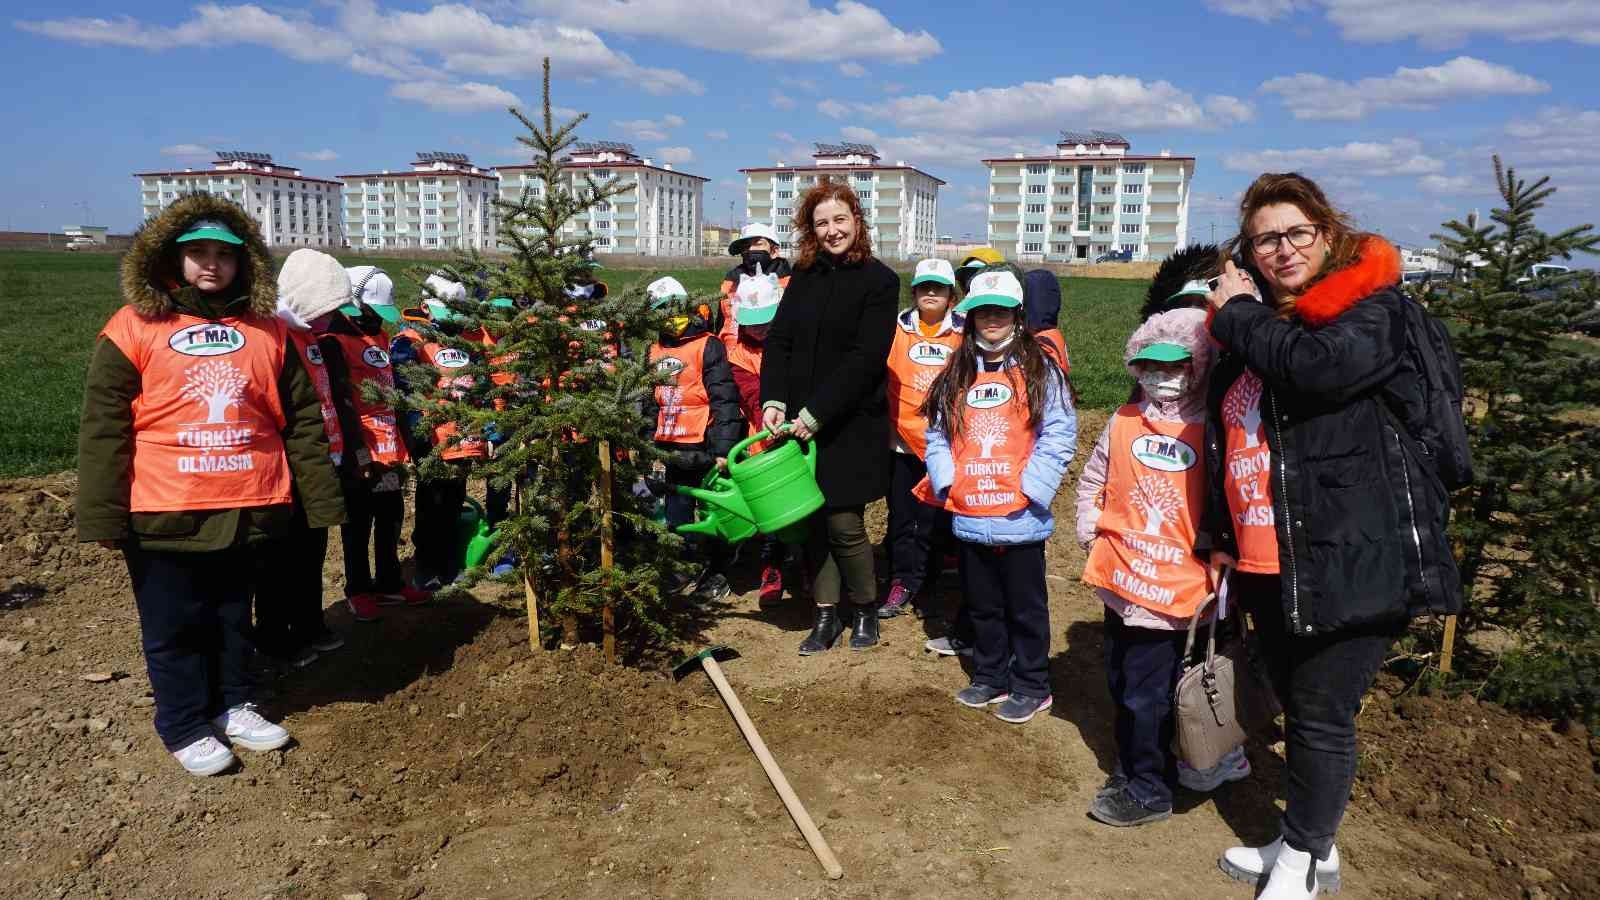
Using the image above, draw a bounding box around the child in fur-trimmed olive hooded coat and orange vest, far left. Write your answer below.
[77,194,344,775]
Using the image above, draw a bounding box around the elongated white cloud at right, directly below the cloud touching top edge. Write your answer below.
[1261,56,1550,120]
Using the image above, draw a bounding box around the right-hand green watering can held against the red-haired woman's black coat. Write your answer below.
[728,429,822,543]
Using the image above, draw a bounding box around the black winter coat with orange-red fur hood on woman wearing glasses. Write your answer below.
[1206,237,1461,636]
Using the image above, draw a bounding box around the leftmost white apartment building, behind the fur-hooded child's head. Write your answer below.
[134,151,344,247]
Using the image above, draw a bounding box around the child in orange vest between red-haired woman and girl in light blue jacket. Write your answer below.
[878,259,971,621]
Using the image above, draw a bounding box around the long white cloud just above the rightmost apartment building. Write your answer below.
[856,75,1253,135]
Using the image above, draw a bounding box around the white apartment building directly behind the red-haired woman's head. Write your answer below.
[739,144,944,259]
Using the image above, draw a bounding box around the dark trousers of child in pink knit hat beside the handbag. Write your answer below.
[1106,609,1187,809]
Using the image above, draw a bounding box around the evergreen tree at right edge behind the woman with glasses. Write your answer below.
[1427,157,1600,721]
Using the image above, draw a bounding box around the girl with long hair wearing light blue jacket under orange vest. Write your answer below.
[918,271,1078,724]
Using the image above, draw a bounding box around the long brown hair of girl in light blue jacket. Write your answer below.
[917,306,1072,437]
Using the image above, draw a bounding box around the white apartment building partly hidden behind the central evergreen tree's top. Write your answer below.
[496,141,710,256]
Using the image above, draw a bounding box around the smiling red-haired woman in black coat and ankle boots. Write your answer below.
[762,181,899,657]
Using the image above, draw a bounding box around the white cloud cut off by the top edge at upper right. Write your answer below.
[1206,0,1600,46]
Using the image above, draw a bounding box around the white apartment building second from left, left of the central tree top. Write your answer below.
[339,151,498,250]
